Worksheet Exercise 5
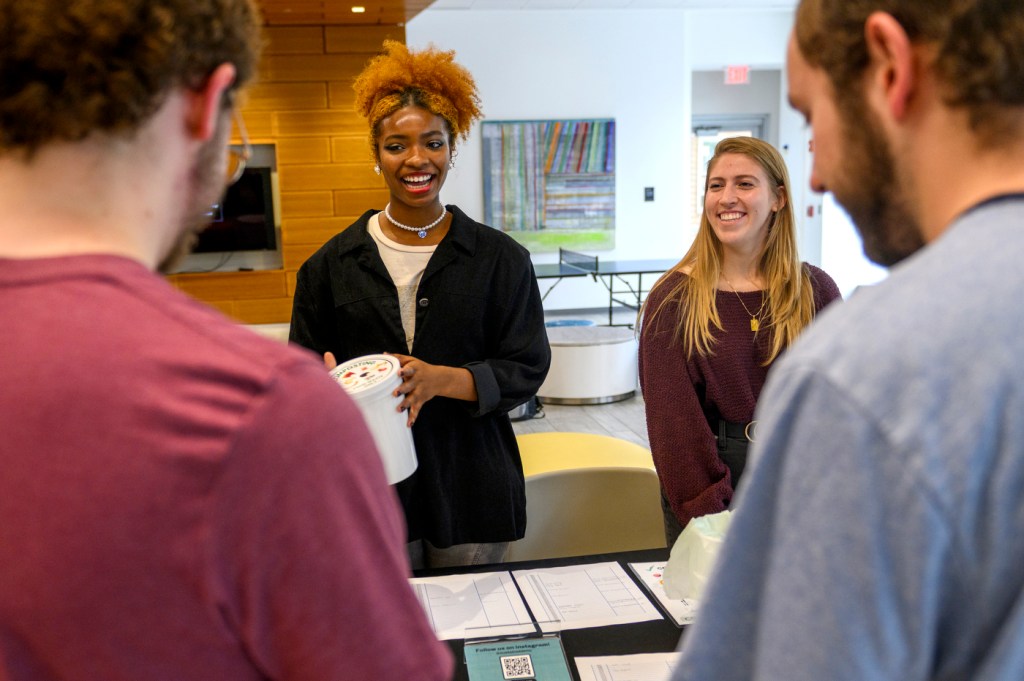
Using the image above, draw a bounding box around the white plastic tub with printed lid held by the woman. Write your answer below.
[331,354,418,484]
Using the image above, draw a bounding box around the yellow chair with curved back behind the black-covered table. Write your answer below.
[508,433,665,561]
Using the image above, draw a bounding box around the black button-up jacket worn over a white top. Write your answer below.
[291,206,551,548]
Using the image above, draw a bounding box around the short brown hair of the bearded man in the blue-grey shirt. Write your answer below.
[796,0,1024,144]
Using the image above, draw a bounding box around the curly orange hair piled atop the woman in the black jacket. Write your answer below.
[352,40,480,158]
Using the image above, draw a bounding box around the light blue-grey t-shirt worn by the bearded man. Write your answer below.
[673,196,1024,681]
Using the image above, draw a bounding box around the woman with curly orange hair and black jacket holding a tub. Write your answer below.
[291,41,551,566]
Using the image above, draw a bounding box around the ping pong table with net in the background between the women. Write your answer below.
[534,248,679,327]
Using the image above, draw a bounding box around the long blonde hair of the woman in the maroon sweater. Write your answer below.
[640,137,814,366]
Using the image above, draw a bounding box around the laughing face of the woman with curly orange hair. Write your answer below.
[377,107,452,216]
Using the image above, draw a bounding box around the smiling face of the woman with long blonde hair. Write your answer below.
[705,154,785,254]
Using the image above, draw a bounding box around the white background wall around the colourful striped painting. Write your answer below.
[406,8,820,309]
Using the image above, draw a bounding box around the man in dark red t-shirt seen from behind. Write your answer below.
[0,0,452,681]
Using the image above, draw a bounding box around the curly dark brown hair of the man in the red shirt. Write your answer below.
[0,0,261,157]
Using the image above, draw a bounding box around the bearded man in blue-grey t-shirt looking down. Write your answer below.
[674,0,1024,681]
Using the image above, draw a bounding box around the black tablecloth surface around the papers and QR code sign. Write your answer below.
[414,548,684,681]
